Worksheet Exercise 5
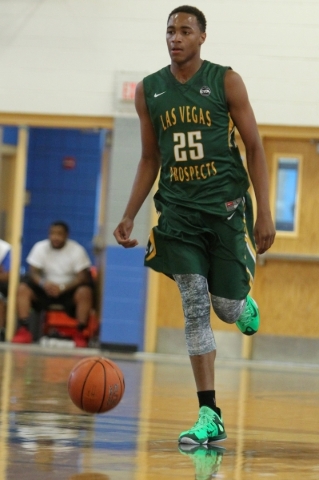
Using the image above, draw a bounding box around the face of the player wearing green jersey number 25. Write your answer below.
[166,12,206,64]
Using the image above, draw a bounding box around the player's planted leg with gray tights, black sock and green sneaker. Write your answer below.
[174,274,226,444]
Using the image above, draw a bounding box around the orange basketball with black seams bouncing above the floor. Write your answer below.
[68,357,125,413]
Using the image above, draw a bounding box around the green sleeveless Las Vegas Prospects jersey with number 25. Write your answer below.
[143,60,249,216]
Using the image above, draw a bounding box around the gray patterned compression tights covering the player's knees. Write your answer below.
[174,274,246,355]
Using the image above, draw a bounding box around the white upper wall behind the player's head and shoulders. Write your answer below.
[0,0,319,126]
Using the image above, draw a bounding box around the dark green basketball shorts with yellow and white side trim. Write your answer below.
[144,193,256,300]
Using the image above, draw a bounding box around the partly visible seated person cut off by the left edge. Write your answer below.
[0,239,11,342]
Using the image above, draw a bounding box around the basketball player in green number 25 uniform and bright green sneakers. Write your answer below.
[114,6,275,445]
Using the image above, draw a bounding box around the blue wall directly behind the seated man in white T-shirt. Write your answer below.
[22,128,105,266]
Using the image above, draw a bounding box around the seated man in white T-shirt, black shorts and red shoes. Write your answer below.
[12,221,93,347]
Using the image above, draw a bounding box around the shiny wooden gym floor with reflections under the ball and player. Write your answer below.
[0,344,319,480]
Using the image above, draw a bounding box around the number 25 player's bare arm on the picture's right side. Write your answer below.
[225,70,276,253]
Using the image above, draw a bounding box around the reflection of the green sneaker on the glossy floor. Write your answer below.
[178,443,225,480]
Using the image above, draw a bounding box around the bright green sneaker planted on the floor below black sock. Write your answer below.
[178,407,227,445]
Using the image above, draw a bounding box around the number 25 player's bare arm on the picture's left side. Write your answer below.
[113,82,161,248]
